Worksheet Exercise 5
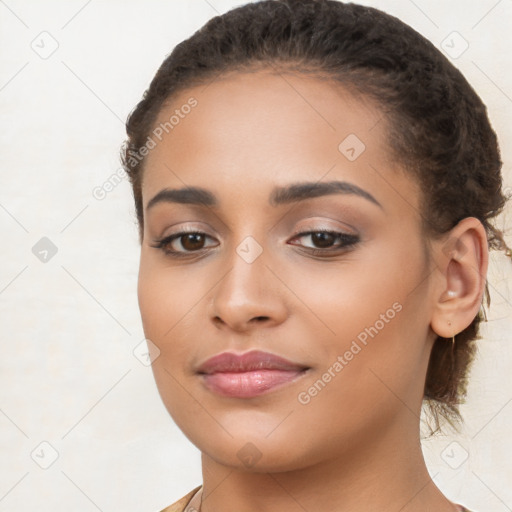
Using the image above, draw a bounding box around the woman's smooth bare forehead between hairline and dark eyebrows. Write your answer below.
[142,70,416,212]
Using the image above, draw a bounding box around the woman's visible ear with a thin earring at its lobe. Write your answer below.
[430,217,489,338]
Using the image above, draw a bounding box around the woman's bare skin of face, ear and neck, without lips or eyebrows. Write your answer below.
[138,70,487,512]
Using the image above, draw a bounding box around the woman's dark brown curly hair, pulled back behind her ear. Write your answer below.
[121,0,510,430]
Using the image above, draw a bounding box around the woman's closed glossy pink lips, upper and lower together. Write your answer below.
[197,350,309,398]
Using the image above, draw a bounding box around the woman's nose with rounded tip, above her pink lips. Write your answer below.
[210,243,288,332]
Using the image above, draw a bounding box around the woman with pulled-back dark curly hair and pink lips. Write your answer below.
[123,0,507,512]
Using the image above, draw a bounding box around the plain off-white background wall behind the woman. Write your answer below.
[0,0,512,512]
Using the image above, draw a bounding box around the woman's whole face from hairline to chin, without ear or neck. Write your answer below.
[138,71,434,471]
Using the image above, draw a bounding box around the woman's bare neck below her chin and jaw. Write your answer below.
[196,411,457,512]
